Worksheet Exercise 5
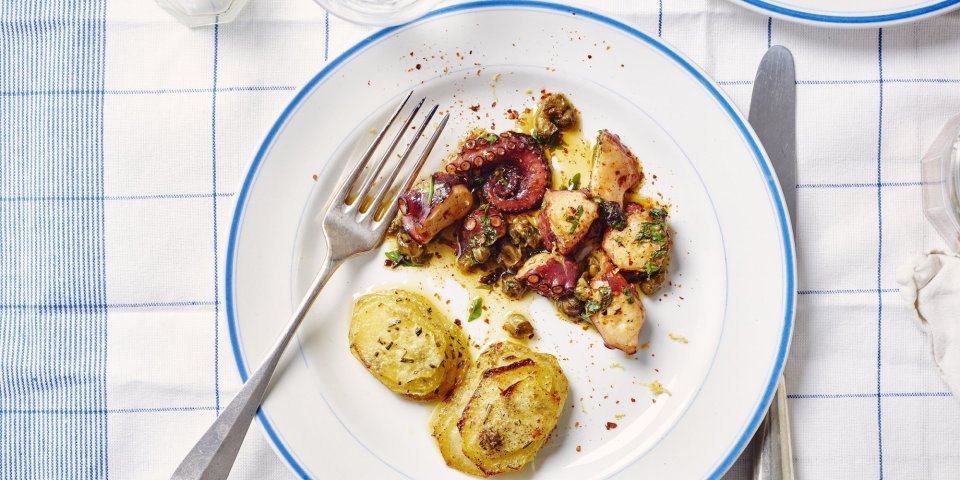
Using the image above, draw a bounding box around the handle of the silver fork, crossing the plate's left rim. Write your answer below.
[171,253,340,480]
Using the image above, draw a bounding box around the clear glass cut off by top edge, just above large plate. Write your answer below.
[316,0,440,27]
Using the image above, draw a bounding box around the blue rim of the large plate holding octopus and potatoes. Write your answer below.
[225,0,796,479]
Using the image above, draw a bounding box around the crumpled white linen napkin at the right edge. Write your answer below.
[897,250,960,399]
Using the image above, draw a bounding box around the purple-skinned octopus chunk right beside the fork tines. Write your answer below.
[398,172,474,244]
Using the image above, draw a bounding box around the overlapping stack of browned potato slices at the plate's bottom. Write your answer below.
[430,341,568,476]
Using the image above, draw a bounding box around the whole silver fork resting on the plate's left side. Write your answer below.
[171,91,449,480]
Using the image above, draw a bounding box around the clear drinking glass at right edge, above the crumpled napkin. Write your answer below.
[921,115,960,252]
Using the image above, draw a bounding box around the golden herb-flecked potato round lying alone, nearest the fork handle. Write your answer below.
[349,290,470,400]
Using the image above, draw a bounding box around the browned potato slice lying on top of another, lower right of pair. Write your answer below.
[457,351,567,475]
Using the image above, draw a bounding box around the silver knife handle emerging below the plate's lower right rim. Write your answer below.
[753,375,793,480]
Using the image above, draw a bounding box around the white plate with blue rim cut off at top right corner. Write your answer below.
[730,0,960,28]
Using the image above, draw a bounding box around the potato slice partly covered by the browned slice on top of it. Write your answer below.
[430,342,531,476]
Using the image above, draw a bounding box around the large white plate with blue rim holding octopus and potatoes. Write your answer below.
[226,1,795,479]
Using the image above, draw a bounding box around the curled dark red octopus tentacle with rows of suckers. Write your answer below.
[444,132,549,213]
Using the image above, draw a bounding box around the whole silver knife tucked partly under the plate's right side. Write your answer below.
[749,46,797,480]
